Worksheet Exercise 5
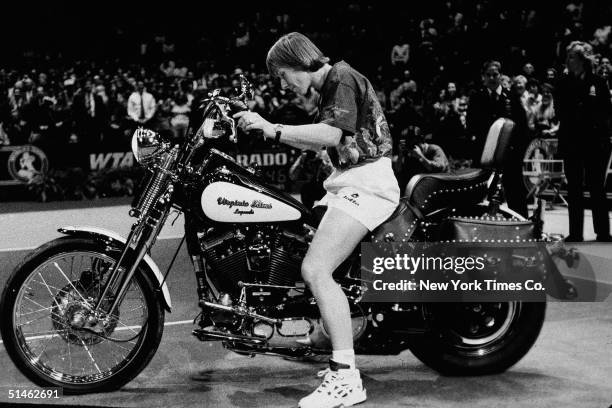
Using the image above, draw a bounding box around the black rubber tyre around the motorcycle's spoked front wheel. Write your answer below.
[0,237,164,394]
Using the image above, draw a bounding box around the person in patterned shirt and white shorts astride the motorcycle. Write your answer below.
[234,33,399,408]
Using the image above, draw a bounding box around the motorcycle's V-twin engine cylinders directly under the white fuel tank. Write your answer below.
[200,226,308,306]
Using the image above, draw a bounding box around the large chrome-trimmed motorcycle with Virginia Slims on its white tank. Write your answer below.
[0,78,576,394]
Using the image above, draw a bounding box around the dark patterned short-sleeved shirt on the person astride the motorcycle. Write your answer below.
[316,61,392,169]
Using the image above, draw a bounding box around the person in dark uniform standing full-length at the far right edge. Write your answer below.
[555,41,612,242]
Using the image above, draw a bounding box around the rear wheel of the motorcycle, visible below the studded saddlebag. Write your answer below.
[410,302,546,376]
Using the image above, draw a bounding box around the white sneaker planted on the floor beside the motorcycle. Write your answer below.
[298,368,367,408]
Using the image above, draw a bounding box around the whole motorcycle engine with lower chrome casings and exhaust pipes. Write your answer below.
[200,226,367,348]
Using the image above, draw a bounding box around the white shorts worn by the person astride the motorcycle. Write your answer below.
[315,157,400,231]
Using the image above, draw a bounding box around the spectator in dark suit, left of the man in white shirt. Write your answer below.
[73,81,108,144]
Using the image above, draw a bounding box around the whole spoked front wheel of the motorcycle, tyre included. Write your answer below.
[0,237,164,394]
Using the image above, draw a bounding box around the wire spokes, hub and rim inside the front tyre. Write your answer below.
[12,250,149,384]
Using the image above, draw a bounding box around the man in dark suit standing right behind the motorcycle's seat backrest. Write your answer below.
[467,61,529,217]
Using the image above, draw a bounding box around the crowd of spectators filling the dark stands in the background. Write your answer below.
[0,0,612,169]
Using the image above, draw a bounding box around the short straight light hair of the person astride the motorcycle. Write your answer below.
[266,32,329,76]
